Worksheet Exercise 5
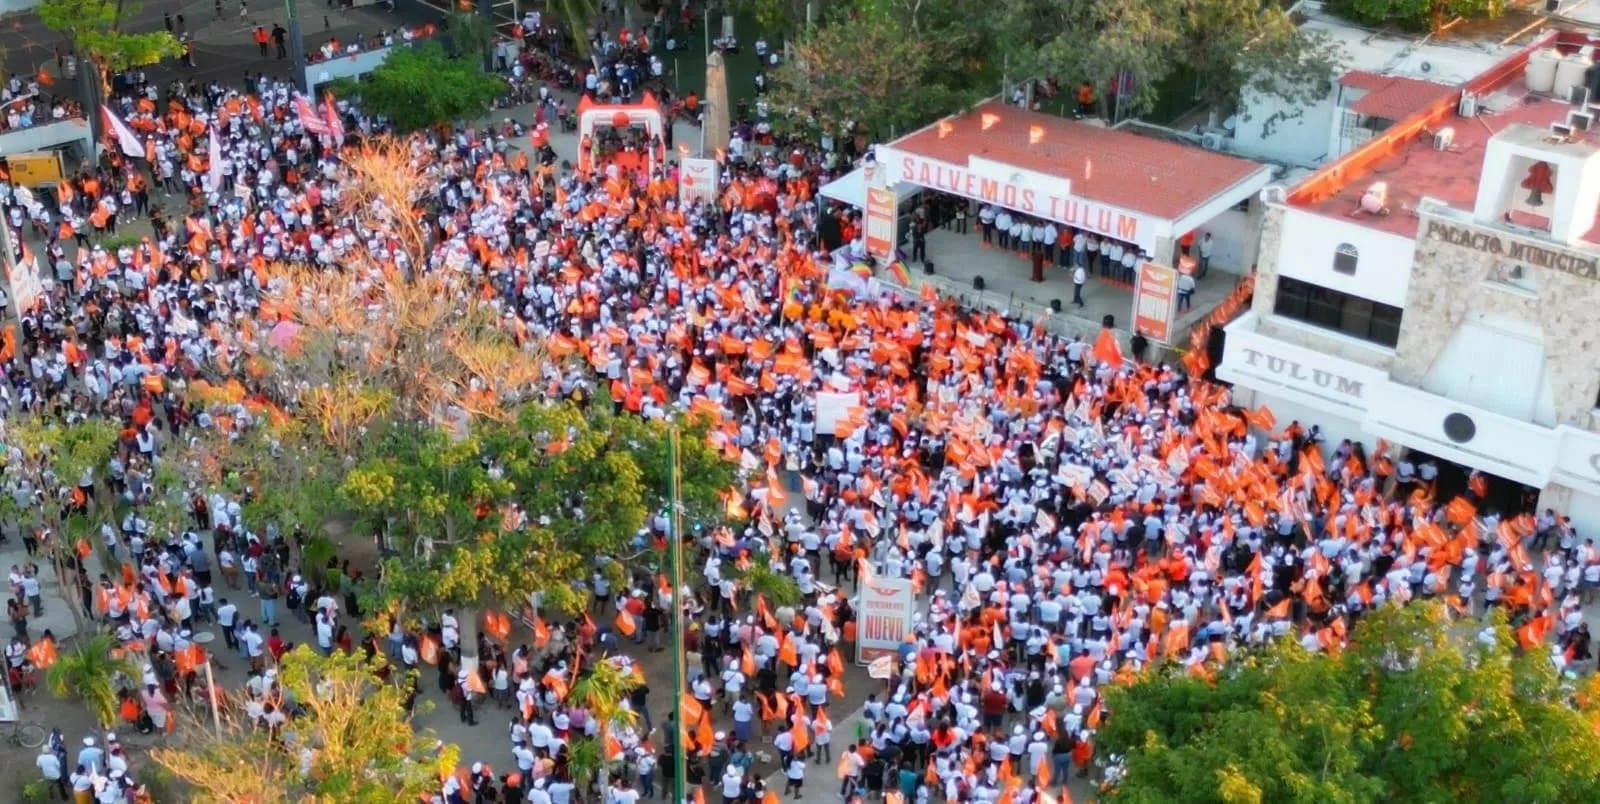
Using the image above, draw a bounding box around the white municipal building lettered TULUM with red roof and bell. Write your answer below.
[1216,34,1600,537]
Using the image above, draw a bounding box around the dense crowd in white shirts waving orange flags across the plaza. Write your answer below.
[0,22,1600,804]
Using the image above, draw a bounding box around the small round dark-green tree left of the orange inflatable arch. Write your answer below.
[333,42,506,131]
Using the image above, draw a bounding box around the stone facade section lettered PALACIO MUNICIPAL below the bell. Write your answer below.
[1390,211,1600,429]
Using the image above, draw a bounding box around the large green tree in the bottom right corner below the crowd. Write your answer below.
[1096,605,1600,802]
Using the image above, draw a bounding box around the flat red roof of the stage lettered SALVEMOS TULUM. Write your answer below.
[893,101,1261,219]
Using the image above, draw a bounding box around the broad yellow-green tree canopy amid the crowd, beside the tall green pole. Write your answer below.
[353,400,734,612]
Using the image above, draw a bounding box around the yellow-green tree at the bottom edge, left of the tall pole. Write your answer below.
[150,645,461,804]
